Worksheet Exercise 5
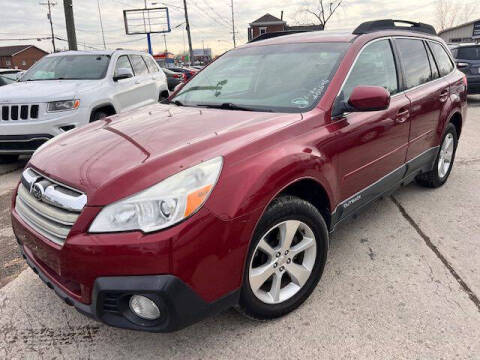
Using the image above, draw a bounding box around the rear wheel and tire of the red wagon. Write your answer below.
[416,124,458,188]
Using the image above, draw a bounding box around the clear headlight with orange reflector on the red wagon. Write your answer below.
[89,157,223,233]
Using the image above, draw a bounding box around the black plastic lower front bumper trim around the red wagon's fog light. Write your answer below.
[20,245,239,332]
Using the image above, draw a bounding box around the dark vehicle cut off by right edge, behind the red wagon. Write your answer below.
[450,44,480,94]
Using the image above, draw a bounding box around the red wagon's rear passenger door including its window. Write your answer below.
[394,38,450,165]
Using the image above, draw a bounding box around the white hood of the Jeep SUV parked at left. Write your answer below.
[0,80,98,103]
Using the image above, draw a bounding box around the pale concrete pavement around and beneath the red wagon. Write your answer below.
[0,97,480,359]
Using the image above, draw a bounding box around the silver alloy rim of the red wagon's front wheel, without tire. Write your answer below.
[248,220,317,304]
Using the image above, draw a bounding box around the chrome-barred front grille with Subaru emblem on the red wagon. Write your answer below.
[15,169,86,245]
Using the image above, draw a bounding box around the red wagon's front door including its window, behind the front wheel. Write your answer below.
[336,39,410,216]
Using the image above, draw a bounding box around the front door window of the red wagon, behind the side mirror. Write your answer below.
[340,40,398,101]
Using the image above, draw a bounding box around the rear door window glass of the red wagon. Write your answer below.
[395,39,431,89]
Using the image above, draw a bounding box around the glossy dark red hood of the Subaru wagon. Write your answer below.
[30,105,302,206]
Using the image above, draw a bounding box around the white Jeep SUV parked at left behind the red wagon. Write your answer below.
[0,50,169,162]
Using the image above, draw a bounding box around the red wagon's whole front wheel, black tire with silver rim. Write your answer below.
[238,196,328,320]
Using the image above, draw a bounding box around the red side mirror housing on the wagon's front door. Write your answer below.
[348,86,390,112]
